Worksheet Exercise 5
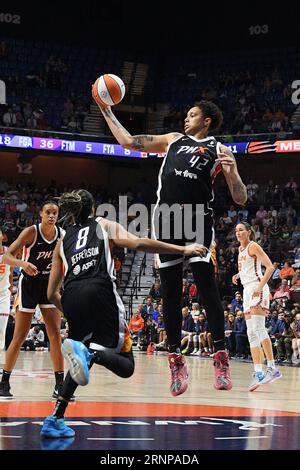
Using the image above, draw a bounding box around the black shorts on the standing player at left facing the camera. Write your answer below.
[18,274,55,313]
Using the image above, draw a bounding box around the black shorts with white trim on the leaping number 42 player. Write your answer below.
[152,211,215,268]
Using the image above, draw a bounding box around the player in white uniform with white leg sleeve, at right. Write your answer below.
[232,222,281,392]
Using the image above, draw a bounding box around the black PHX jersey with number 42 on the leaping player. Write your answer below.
[157,135,221,204]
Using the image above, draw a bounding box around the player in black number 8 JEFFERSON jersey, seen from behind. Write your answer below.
[41,190,207,438]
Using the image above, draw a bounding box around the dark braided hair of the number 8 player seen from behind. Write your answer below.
[58,189,95,226]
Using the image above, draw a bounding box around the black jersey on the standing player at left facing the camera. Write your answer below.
[22,224,64,279]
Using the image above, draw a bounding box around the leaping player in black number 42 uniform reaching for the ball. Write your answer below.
[95,99,247,395]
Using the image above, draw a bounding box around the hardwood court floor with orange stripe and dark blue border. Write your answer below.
[0,352,300,450]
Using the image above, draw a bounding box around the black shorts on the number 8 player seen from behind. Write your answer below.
[61,279,131,352]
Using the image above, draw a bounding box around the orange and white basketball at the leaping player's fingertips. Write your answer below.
[92,73,125,106]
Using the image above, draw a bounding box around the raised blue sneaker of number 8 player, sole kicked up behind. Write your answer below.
[61,338,93,385]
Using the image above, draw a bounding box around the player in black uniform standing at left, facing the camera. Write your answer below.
[0,201,64,398]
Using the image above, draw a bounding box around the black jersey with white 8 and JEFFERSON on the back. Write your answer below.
[61,217,114,288]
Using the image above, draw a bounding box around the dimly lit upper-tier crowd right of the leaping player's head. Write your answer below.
[163,67,293,135]
